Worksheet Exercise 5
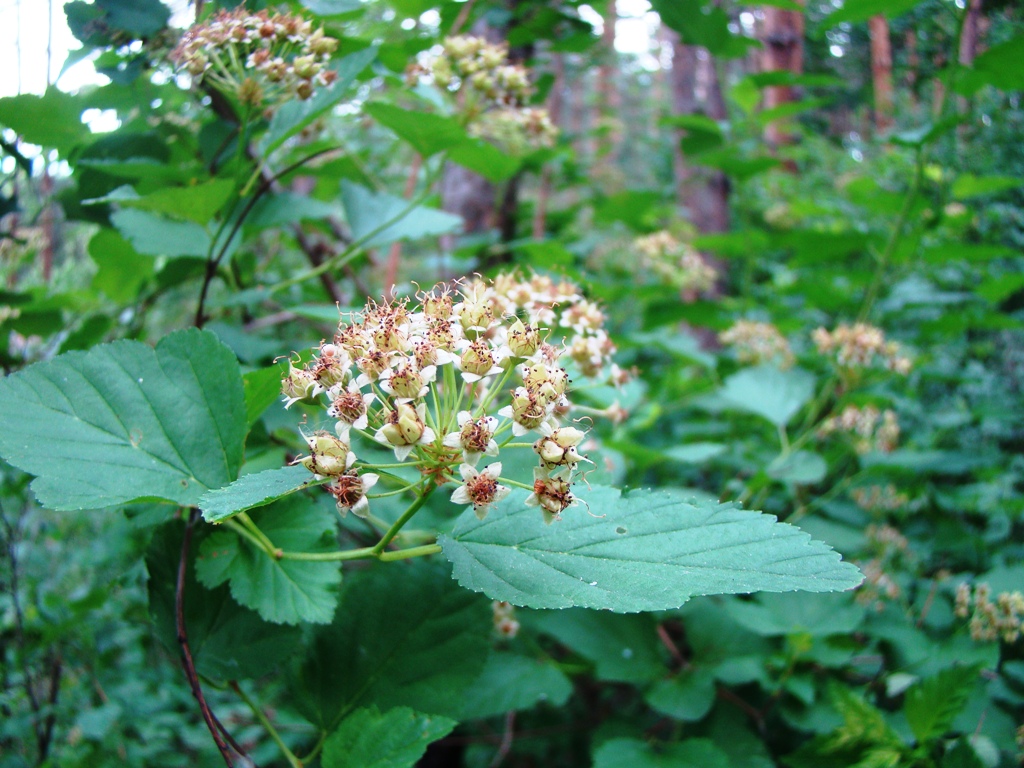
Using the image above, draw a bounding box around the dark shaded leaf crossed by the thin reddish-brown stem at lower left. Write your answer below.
[145,520,300,680]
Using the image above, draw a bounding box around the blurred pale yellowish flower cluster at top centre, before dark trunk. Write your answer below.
[409,36,558,154]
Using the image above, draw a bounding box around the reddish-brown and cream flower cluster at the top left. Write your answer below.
[171,6,338,108]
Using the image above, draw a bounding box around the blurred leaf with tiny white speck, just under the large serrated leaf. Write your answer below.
[530,609,665,683]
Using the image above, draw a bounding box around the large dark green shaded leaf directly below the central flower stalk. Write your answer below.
[292,562,493,730]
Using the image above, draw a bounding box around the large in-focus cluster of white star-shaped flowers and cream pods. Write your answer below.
[283,274,614,522]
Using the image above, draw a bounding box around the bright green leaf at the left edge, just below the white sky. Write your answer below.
[0,86,91,156]
